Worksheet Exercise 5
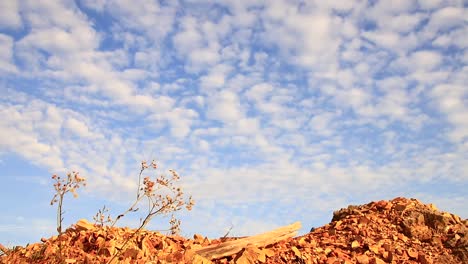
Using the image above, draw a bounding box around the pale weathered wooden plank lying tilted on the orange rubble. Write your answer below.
[195,222,301,259]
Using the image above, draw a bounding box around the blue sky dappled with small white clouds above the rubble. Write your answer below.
[0,0,468,245]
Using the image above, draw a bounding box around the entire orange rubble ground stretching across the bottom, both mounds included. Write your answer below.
[0,198,468,264]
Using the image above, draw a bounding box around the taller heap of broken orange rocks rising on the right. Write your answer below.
[268,198,468,264]
